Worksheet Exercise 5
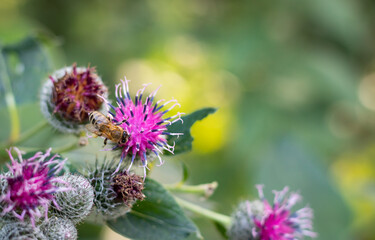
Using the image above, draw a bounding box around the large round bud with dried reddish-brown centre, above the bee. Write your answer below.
[41,64,108,133]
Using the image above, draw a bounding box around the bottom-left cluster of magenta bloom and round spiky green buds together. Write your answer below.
[0,148,94,240]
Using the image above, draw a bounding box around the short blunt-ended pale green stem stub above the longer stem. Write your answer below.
[164,181,217,198]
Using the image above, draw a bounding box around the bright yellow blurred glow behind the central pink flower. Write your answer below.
[117,36,240,154]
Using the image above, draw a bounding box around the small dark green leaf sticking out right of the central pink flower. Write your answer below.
[165,108,216,155]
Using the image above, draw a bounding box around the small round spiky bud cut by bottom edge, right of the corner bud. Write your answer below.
[40,216,77,240]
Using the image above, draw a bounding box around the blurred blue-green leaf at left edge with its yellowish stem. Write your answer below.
[0,37,50,141]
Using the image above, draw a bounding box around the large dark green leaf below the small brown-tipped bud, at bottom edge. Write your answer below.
[107,178,200,240]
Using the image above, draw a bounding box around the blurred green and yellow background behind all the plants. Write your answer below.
[0,0,375,240]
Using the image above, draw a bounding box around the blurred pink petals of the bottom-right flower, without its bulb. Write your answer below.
[253,185,317,240]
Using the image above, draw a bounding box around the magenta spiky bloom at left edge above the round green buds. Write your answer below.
[0,148,68,226]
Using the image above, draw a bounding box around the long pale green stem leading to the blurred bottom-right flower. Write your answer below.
[174,196,231,228]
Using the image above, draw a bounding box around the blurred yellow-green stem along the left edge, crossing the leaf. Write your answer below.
[0,46,20,142]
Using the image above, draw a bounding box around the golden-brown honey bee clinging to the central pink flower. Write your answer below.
[86,111,129,145]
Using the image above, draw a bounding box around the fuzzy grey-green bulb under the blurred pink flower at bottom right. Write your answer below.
[228,200,264,240]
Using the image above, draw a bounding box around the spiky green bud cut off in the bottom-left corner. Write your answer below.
[0,221,47,240]
